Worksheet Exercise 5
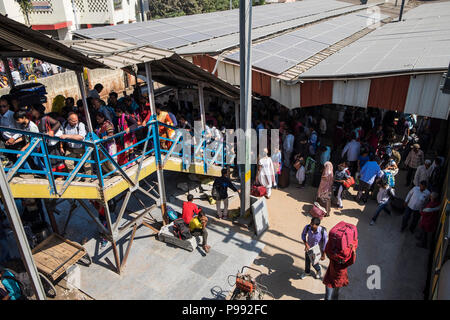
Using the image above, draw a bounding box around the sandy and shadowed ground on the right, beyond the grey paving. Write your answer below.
[246,171,429,300]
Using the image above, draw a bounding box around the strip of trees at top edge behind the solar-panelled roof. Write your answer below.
[149,0,265,19]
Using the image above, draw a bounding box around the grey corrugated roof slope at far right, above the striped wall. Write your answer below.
[300,2,450,79]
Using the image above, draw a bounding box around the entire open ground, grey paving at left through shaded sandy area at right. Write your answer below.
[46,171,429,300]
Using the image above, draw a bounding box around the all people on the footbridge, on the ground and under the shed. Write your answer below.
[0,79,445,299]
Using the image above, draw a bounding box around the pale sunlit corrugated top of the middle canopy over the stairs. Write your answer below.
[61,39,174,69]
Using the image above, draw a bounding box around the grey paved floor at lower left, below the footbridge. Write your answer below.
[51,173,264,300]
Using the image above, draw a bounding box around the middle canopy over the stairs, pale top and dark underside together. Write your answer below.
[61,40,239,100]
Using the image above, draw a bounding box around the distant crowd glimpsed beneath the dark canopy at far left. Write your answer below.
[0,58,64,88]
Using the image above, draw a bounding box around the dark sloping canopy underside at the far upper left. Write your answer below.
[0,14,108,71]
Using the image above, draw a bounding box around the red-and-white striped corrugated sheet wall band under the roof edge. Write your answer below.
[192,55,450,119]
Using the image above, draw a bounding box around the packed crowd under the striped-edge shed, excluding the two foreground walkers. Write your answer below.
[254,107,445,234]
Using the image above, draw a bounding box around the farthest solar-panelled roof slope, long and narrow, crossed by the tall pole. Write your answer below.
[75,0,359,54]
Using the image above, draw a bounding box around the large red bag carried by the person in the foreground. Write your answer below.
[325,221,358,264]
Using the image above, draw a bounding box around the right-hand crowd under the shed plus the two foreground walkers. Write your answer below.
[244,103,445,299]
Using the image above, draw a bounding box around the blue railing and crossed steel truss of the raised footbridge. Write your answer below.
[0,121,234,274]
